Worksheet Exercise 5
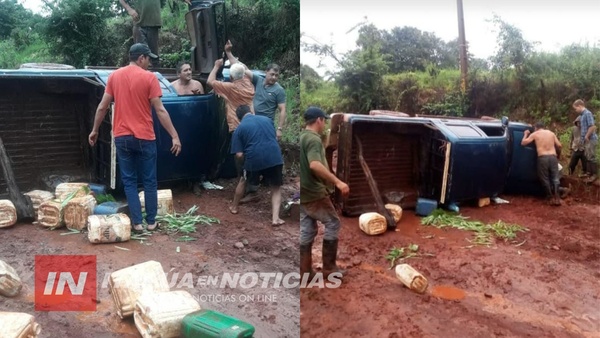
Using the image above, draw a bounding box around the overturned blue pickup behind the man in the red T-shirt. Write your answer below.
[0,0,246,192]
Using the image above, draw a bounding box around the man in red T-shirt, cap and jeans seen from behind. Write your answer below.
[89,43,181,231]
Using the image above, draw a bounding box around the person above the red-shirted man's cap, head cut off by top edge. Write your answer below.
[119,0,191,68]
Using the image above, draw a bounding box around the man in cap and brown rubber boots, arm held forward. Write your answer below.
[300,107,350,279]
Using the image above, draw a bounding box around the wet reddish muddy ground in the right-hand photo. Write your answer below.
[300,180,600,337]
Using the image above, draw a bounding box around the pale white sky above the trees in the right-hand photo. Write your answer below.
[300,0,600,75]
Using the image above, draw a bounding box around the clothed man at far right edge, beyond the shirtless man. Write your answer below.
[573,100,598,183]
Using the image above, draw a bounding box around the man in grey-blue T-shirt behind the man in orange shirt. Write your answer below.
[225,40,286,140]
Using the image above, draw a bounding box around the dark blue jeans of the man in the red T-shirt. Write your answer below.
[115,135,158,225]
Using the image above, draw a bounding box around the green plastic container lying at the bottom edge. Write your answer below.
[181,310,254,338]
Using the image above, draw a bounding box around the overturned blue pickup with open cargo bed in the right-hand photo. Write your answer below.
[326,114,541,216]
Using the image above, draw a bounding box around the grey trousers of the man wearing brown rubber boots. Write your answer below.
[300,197,341,245]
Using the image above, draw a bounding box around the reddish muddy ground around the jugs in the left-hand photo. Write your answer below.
[0,177,300,338]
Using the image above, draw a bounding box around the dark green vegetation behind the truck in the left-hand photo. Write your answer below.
[0,0,301,143]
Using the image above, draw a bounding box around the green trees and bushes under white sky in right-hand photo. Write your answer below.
[300,16,600,141]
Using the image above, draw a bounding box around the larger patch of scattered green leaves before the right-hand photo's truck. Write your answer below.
[421,209,529,246]
